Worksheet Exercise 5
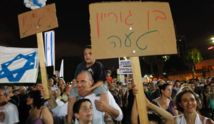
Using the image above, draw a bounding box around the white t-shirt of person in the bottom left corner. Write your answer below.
[0,102,19,124]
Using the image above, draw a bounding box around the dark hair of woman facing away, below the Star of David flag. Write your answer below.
[28,90,45,109]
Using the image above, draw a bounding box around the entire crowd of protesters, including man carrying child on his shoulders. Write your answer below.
[0,44,214,124]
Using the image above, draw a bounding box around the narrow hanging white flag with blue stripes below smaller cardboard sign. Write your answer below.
[45,31,55,66]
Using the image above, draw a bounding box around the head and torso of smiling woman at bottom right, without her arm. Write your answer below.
[174,87,214,124]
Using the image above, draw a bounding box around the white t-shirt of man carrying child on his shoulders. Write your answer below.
[75,91,123,124]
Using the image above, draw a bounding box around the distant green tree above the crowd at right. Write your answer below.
[187,48,203,78]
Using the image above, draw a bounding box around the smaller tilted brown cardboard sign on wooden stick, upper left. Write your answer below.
[18,4,58,38]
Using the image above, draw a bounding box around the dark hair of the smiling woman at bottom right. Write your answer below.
[175,87,200,112]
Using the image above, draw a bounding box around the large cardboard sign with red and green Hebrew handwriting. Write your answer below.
[89,2,177,59]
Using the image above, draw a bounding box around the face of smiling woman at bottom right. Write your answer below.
[180,92,197,113]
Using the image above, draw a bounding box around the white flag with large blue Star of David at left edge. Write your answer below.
[0,46,38,83]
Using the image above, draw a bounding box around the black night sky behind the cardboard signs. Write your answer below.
[0,0,214,57]
